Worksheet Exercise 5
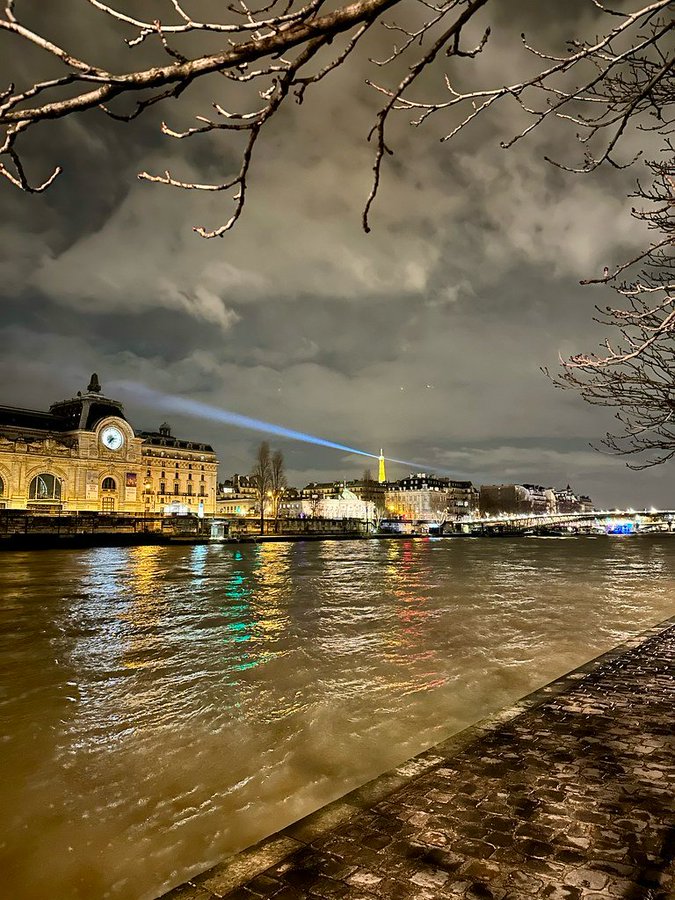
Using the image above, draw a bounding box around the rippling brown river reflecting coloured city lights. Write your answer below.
[0,536,675,900]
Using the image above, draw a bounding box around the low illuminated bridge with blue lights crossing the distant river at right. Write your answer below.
[444,509,675,535]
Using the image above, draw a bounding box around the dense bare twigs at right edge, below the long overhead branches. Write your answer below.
[547,150,675,469]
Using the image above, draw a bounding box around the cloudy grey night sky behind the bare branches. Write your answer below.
[0,0,675,508]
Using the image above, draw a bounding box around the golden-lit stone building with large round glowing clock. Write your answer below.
[0,375,218,515]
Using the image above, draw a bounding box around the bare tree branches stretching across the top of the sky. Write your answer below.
[0,0,675,237]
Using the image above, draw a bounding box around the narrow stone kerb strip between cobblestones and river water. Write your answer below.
[160,616,675,900]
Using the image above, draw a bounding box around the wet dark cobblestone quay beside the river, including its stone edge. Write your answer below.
[166,625,675,900]
